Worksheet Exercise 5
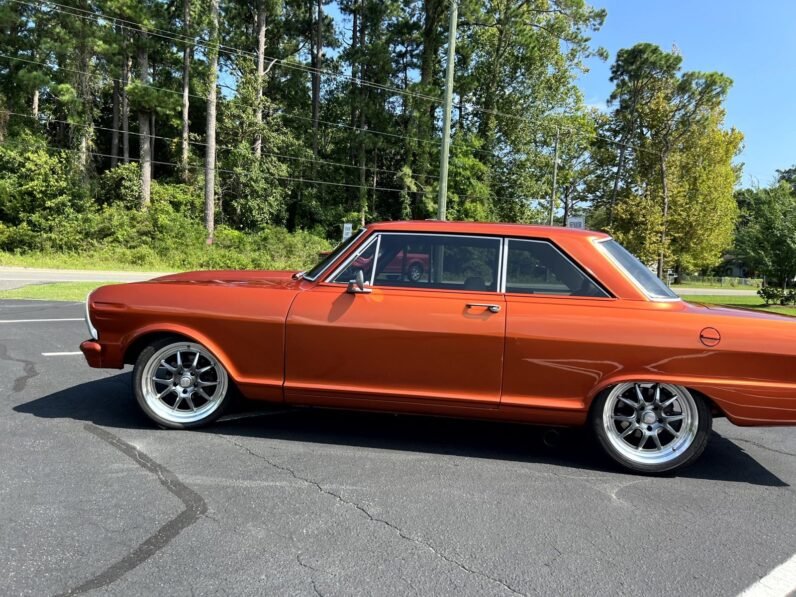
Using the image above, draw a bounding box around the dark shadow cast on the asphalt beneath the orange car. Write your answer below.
[14,372,788,487]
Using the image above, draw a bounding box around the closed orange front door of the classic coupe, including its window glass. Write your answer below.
[285,232,505,407]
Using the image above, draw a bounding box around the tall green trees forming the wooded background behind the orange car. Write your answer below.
[0,0,784,278]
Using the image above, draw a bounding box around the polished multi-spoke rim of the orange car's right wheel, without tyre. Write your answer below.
[603,382,699,464]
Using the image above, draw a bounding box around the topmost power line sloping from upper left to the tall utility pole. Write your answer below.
[11,0,442,103]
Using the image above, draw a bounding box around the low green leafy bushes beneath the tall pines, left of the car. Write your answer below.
[0,136,329,269]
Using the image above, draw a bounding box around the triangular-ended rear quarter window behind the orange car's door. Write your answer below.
[506,239,608,297]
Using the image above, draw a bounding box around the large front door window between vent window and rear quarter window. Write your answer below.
[374,234,500,292]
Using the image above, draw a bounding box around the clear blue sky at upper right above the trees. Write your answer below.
[578,0,796,186]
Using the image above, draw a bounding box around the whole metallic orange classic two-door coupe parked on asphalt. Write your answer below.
[81,221,796,473]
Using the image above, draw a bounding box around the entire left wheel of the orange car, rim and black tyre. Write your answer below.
[133,338,229,429]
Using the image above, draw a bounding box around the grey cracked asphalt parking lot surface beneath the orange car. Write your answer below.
[0,301,796,595]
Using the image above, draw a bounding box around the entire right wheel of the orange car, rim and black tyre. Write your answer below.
[591,382,712,474]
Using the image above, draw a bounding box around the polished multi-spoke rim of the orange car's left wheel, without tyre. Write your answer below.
[141,342,228,424]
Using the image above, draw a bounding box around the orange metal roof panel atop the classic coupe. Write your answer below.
[367,220,611,240]
